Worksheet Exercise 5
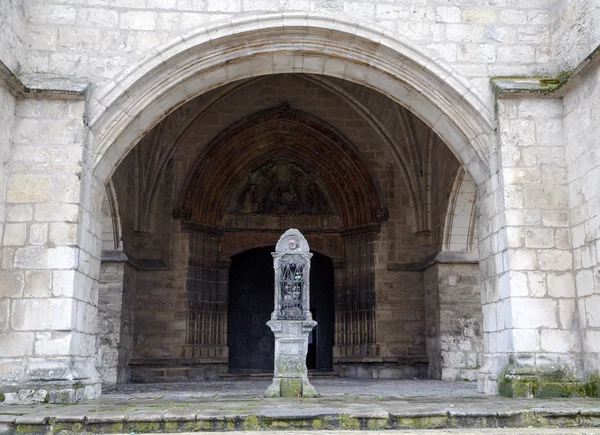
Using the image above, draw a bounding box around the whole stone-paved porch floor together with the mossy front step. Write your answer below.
[0,378,600,435]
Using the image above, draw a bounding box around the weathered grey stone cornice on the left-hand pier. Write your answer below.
[0,61,90,100]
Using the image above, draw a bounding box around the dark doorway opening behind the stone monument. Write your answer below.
[227,247,334,373]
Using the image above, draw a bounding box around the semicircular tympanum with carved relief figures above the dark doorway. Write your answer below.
[229,159,337,215]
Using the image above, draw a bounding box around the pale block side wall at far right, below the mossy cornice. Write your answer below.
[557,61,600,374]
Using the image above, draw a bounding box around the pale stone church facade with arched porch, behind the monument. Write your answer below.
[0,0,600,401]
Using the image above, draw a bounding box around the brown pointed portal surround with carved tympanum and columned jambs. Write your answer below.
[176,105,388,364]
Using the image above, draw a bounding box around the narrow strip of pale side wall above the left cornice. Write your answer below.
[0,0,29,74]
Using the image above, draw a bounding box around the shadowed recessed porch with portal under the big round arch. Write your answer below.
[105,74,481,381]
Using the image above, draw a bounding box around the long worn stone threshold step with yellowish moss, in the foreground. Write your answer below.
[0,397,600,435]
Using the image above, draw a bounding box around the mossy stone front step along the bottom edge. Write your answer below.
[0,403,600,435]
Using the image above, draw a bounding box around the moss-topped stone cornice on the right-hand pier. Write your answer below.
[491,46,600,98]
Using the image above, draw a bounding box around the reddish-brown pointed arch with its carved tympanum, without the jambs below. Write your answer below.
[178,106,385,227]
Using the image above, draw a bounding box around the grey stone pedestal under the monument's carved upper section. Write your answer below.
[265,320,317,397]
